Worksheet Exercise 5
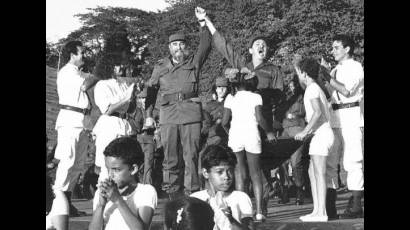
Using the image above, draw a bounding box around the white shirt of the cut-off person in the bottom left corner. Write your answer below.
[46,190,69,230]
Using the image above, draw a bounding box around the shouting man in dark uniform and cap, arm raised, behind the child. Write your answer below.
[199,8,285,217]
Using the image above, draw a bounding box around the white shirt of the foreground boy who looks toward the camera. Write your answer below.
[191,190,253,226]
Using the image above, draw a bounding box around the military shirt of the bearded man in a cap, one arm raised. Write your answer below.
[146,28,211,124]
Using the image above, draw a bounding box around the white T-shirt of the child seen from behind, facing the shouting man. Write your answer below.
[224,91,262,143]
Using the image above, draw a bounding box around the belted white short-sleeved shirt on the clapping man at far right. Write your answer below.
[330,59,364,128]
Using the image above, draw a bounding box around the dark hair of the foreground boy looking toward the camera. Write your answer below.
[201,145,237,171]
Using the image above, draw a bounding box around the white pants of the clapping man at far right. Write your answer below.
[326,127,364,191]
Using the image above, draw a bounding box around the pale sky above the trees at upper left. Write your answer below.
[46,0,169,42]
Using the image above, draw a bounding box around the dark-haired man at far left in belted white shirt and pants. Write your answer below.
[53,41,97,216]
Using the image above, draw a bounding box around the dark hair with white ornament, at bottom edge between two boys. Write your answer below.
[164,197,215,230]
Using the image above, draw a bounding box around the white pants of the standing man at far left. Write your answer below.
[53,127,88,192]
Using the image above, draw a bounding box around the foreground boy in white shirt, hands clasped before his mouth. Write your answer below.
[89,137,157,230]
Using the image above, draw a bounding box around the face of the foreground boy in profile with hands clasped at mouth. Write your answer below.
[105,157,138,189]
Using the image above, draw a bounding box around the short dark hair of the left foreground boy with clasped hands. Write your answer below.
[104,137,144,167]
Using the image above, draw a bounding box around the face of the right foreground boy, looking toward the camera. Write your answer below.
[202,163,234,192]
